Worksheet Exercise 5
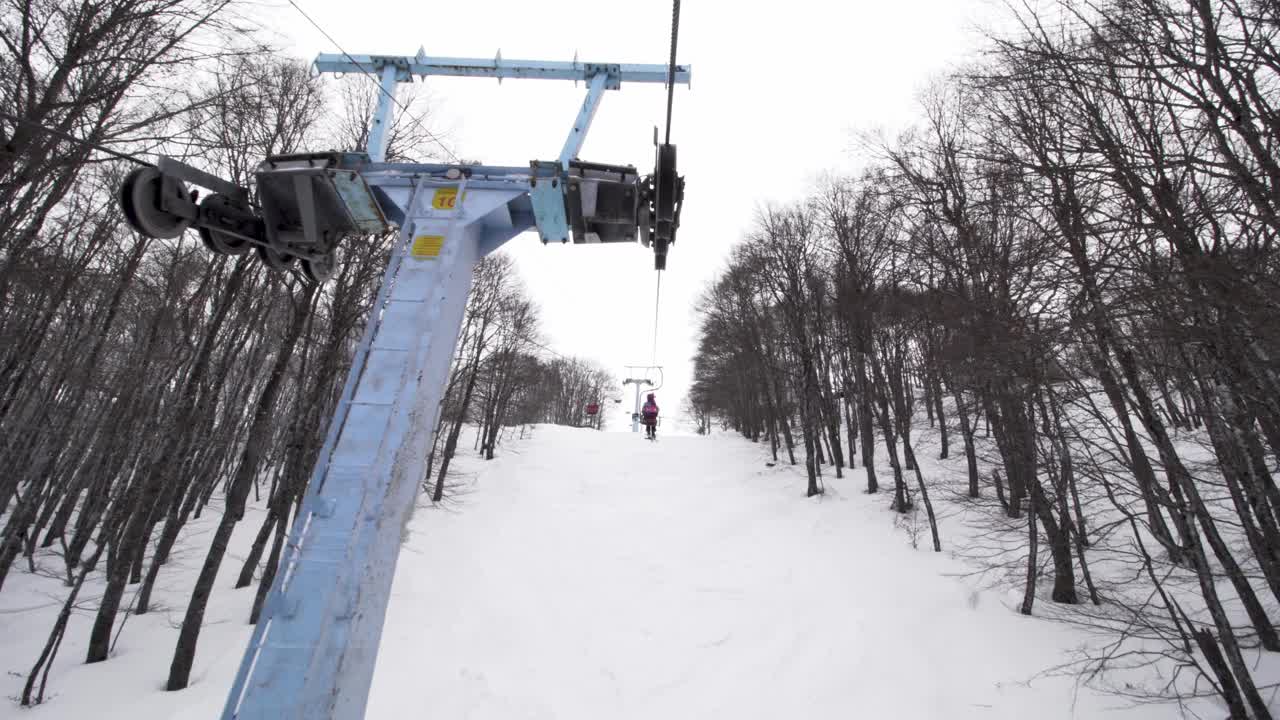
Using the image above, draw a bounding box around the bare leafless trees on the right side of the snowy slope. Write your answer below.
[691,0,1280,719]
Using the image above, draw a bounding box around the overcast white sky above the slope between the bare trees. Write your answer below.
[272,0,1001,414]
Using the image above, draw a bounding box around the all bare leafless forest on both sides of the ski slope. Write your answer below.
[0,0,1280,720]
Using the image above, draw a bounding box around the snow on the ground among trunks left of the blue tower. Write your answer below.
[0,495,265,720]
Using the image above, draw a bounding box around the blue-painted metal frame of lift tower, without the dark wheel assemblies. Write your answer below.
[223,47,690,720]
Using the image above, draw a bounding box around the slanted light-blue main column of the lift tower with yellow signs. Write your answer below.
[223,177,527,720]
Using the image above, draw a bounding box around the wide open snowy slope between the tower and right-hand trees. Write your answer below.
[367,427,1171,720]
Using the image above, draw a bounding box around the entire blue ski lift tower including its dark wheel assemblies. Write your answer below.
[120,51,690,720]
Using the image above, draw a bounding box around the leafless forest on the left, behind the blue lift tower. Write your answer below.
[0,0,612,705]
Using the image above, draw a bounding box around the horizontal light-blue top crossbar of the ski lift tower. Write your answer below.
[315,54,692,90]
